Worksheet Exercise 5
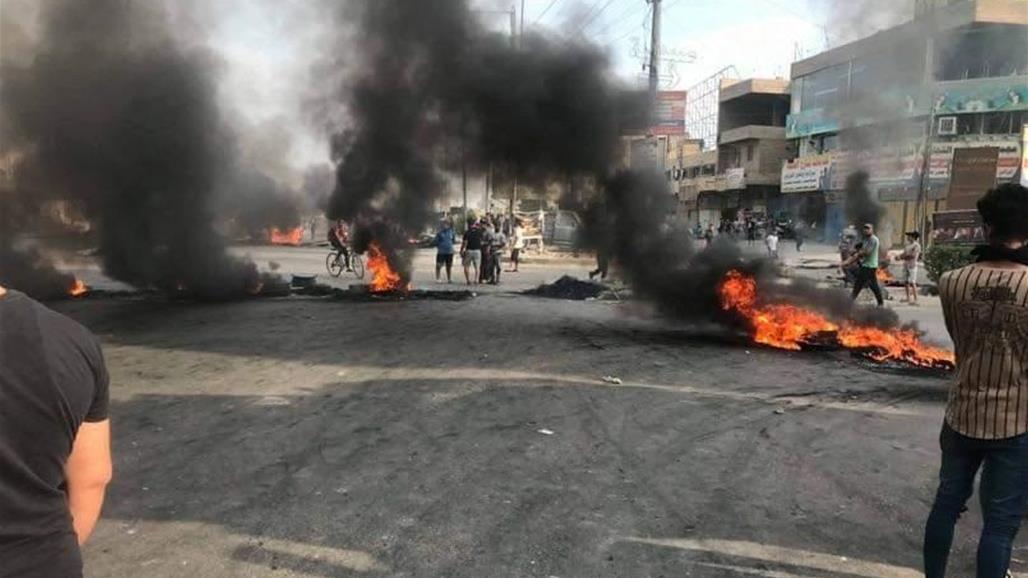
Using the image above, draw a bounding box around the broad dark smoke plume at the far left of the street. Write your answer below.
[0,0,300,298]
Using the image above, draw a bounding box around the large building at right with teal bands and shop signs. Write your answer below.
[781,0,1028,245]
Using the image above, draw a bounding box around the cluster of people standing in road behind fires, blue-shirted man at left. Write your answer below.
[435,214,524,285]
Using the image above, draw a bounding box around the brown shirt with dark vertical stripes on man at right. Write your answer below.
[939,264,1028,439]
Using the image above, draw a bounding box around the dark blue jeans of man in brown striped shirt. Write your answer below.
[924,425,1028,578]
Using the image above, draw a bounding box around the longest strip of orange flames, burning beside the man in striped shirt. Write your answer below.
[719,270,956,367]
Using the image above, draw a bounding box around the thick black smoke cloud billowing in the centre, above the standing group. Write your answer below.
[327,0,646,279]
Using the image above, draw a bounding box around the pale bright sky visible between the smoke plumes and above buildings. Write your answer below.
[202,0,892,174]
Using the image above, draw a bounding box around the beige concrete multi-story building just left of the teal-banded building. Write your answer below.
[669,78,792,226]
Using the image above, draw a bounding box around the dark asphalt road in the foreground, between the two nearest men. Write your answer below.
[50,281,1028,578]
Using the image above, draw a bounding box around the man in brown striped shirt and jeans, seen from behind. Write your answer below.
[924,184,1028,578]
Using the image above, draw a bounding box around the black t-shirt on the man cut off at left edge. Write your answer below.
[0,291,108,578]
